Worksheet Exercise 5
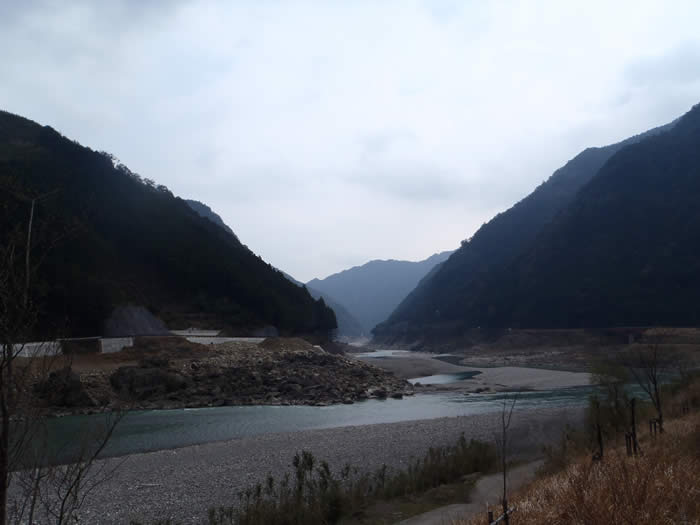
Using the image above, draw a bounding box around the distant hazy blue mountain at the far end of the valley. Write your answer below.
[307,252,452,335]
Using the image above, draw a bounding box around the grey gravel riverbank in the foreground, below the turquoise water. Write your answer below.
[69,408,582,524]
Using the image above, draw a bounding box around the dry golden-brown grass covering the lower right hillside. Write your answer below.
[461,415,700,525]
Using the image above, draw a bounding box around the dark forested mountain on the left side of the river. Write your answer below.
[0,112,336,336]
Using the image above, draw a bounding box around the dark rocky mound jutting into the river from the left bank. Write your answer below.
[35,338,413,413]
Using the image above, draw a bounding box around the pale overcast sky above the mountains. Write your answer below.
[0,0,700,281]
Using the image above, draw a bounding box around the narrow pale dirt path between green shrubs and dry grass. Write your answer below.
[399,461,542,525]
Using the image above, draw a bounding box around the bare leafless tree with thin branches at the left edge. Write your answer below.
[0,187,122,525]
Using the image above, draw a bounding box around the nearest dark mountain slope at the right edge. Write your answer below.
[490,105,700,327]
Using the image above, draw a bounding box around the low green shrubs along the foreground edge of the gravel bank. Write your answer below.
[132,435,497,525]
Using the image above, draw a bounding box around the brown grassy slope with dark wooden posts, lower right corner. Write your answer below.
[462,370,700,525]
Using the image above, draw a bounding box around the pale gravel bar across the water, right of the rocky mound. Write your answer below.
[361,352,590,391]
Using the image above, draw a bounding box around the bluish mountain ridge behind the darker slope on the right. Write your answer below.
[375,110,678,341]
